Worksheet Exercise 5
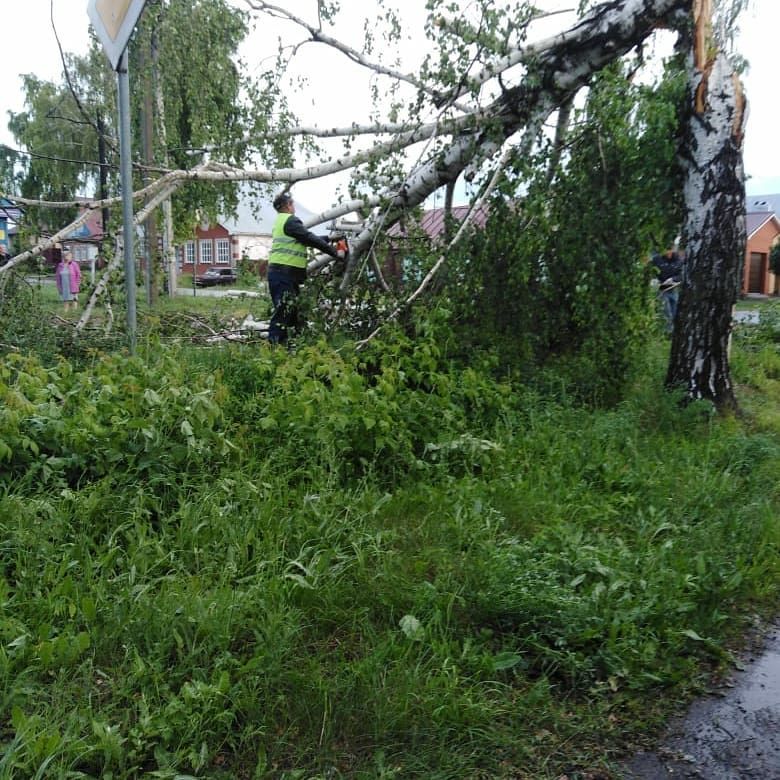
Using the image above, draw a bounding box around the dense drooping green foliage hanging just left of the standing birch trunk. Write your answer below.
[452,65,683,403]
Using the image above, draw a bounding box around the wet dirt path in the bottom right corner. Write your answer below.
[623,623,780,780]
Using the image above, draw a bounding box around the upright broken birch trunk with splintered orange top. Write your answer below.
[666,0,746,411]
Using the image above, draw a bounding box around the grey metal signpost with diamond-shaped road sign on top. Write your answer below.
[87,0,146,352]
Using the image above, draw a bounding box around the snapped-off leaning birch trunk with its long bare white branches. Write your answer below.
[0,0,700,322]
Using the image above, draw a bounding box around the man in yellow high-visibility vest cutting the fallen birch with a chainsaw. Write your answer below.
[268,192,345,344]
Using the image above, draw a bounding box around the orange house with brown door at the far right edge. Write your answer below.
[742,195,780,295]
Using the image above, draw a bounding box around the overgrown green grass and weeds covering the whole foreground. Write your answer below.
[0,304,780,778]
